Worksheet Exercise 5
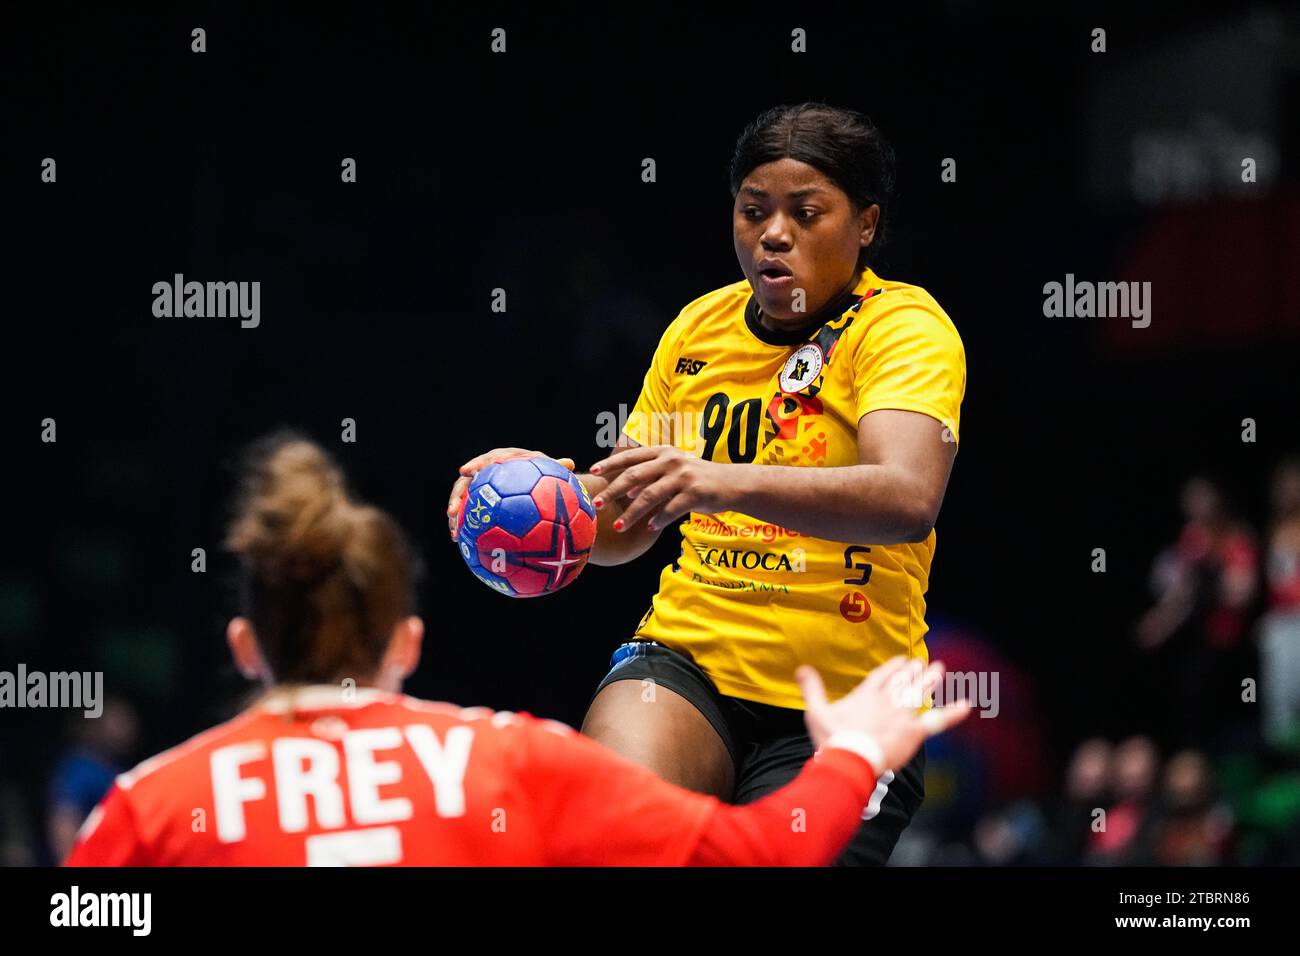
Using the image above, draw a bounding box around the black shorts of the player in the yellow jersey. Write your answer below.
[593,641,926,866]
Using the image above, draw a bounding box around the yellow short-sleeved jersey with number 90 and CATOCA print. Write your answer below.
[623,269,966,709]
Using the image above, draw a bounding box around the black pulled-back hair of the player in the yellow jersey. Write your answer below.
[731,103,894,269]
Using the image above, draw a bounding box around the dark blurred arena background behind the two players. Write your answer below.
[0,1,1300,936]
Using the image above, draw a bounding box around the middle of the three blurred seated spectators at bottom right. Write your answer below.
[1083,736,1160,866]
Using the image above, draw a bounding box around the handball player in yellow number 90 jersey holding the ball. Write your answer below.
[449,103,966,865]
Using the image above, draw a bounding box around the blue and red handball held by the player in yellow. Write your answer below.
[456,455,595,597]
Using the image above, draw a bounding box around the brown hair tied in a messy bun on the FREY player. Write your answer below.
[226,432,419,683]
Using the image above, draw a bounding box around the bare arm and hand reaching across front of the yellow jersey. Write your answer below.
[592,408,957,544]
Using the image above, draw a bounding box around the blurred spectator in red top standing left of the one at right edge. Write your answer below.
[1138,477,1258,745]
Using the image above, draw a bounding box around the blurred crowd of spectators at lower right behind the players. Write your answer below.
[892,458,1300,866]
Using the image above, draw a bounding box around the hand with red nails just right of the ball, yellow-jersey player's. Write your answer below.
[592,445,736,531]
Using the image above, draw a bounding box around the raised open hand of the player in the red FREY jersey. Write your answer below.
[794,657,971,770]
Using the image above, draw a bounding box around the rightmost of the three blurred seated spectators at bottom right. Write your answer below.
[1141,750,1232,866]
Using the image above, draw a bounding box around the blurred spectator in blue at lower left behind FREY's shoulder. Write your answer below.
[47,698,138,861]
